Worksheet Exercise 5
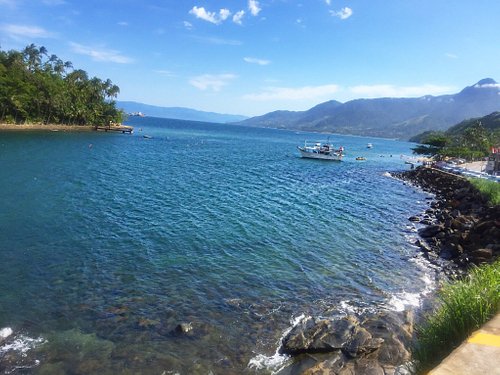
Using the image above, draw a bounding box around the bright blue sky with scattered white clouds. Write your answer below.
[0,0,500,116]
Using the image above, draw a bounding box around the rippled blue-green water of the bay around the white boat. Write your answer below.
[0,118,427,374]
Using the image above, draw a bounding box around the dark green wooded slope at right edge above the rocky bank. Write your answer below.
[412,112,500,160]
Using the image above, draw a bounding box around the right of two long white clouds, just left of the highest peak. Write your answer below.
[348,84,454,98]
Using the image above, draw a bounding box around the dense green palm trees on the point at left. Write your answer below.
[0,44,123,125]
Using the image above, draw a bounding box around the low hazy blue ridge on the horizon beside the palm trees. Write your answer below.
[116,101,248,123]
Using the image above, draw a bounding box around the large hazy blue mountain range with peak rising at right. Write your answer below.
[234,78,500,139]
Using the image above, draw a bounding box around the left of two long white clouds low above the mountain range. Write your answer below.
[244,84,340,101]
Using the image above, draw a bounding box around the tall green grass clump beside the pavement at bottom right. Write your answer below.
[413,260,500,374]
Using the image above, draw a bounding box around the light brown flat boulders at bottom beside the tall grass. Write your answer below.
[280,312,413,375]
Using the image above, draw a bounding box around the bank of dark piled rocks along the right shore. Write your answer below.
[394,167,500,273]
